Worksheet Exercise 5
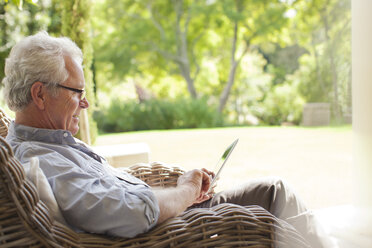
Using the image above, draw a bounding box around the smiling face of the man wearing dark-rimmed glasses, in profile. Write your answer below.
[46,57,89,135]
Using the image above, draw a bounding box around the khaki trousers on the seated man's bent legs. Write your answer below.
[193,178,330,248]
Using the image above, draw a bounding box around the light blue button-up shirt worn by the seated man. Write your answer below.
[6,122,159,237]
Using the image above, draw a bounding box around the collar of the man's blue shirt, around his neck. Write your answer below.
[8,121,76,145]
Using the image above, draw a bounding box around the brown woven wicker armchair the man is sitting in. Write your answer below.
[0,109,309,248]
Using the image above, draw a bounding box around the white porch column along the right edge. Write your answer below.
[352,0,372,208]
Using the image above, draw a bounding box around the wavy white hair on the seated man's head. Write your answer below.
[2,31,83,111]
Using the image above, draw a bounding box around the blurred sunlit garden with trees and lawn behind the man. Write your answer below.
[0,0,351,207]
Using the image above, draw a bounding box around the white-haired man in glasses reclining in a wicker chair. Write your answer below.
[3,32,328,247]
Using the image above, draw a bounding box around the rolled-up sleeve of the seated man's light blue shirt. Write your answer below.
[17,143,159,238]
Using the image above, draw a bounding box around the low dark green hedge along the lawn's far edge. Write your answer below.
[94,98,223,132]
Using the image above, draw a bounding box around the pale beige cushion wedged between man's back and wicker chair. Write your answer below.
[23,157,66,225]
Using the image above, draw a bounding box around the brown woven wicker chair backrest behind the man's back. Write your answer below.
[0,137,73,247]
